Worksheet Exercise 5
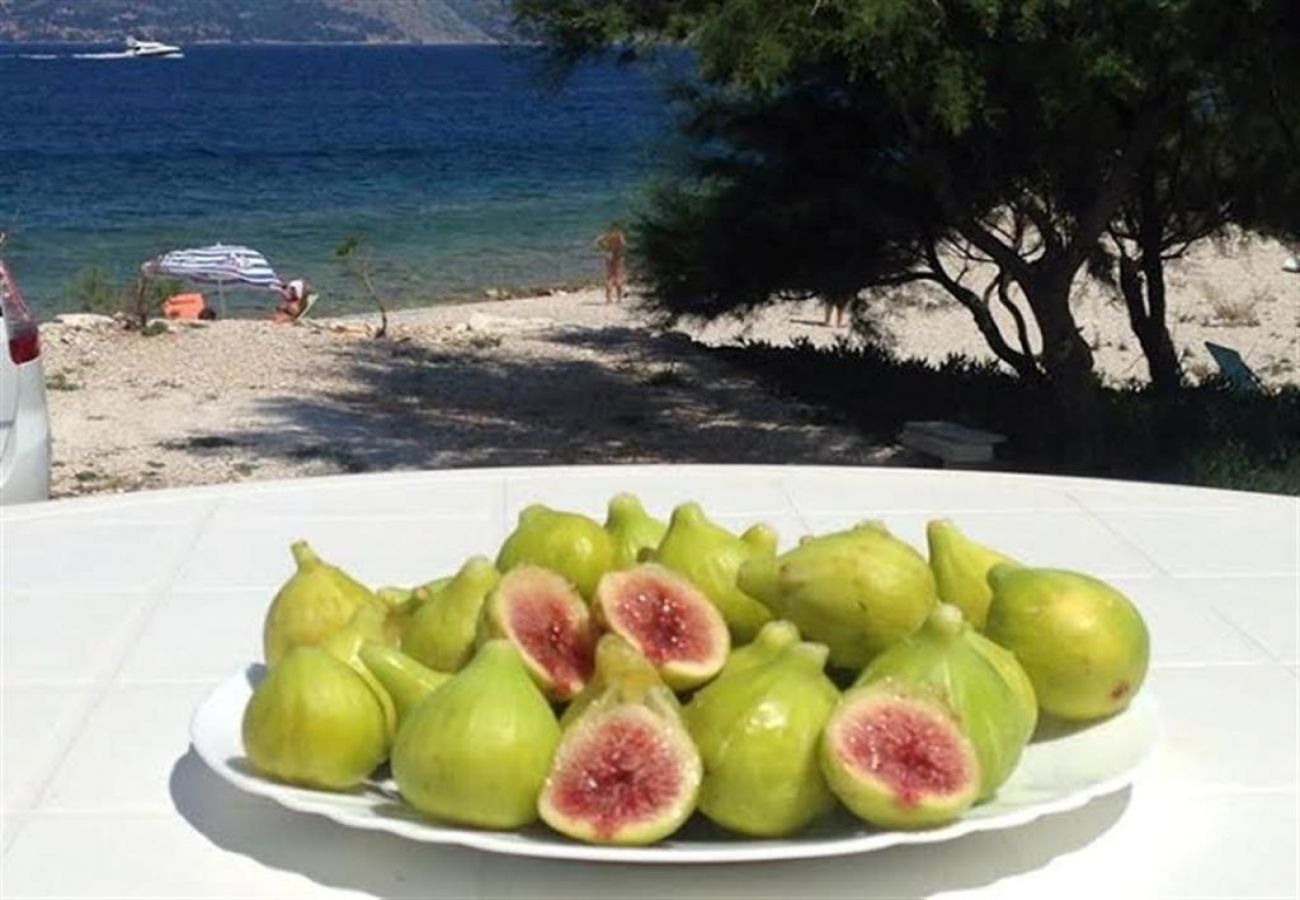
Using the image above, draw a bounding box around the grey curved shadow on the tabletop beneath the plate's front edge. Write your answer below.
[170,750,1130,897]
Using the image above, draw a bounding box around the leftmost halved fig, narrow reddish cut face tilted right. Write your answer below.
[484,566,595,701]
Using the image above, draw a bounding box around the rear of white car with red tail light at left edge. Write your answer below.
[0,251,49,503]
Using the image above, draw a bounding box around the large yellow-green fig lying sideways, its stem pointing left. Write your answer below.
[736,523,937,668]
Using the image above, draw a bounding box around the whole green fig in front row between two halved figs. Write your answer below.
[684,623,840,838]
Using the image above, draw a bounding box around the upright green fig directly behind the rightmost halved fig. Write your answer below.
[857,603,1036,800]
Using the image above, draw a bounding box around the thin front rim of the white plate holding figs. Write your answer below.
[190,666,1162,865]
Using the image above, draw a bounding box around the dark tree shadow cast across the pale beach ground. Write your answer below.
[178,328,889,472]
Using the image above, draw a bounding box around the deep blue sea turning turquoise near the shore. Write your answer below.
[0,44,672,315]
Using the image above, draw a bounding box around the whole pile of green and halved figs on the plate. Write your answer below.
[243,494,1149,844]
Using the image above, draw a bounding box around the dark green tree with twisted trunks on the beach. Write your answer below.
[516,0,1300,433]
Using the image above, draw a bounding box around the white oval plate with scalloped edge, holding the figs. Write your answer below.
[190,666,1160,862]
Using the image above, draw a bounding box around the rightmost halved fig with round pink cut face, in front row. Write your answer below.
[820,683,980,828]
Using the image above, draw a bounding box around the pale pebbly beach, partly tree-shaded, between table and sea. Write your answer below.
[42,235,1300,496]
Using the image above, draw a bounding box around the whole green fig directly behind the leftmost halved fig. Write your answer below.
[497,503,616,598]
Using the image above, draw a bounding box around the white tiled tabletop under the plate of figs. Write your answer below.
[0,466,1300,899]
